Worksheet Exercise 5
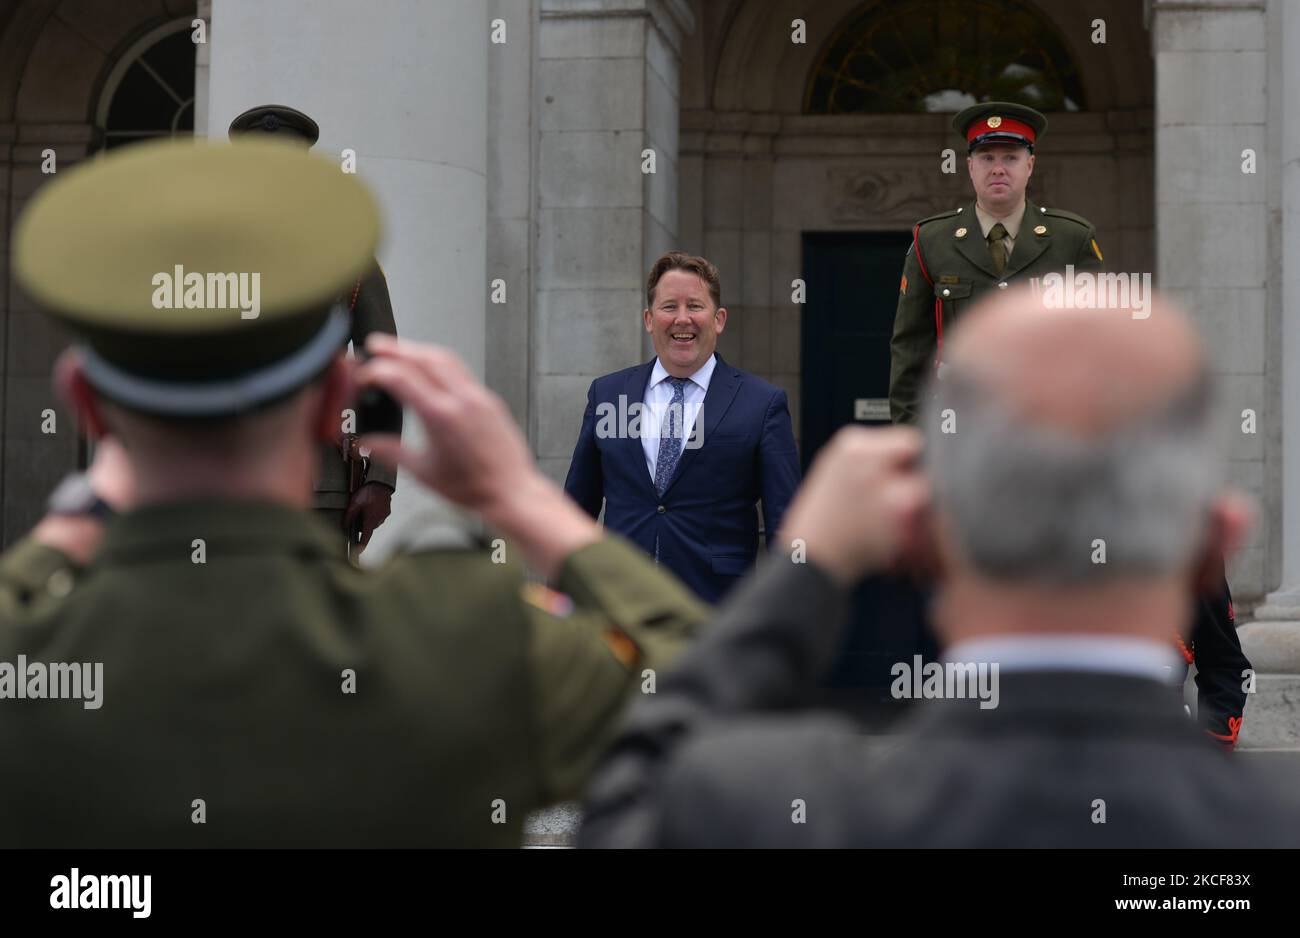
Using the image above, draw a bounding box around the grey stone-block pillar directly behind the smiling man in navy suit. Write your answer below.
[530,0,694,479]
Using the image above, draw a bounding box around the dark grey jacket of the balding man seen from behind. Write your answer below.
[580,559,1300,847]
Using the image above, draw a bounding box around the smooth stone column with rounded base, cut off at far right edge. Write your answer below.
[1239,3,1300,748]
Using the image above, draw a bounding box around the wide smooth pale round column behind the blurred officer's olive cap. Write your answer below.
[208,0,489,560]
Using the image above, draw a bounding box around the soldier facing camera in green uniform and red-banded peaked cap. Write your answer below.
[889,101,1102,424]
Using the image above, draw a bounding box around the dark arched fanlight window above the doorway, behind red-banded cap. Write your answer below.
[803,0,1086,114]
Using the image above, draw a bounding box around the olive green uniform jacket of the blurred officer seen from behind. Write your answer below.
[0,501,707,847]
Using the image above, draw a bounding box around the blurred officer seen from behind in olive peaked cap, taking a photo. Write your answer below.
[0,142,707,847]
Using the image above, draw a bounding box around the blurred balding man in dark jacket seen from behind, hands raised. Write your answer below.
[580,291,1300,847]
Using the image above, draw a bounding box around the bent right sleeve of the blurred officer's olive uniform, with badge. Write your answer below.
[525,537,711,803]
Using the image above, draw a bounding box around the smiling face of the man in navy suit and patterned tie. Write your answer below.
[641,270,727,378]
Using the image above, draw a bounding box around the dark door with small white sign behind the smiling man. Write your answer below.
[801,231,936,726]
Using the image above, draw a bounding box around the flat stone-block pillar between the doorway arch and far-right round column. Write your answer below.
[1152,0,1281,603]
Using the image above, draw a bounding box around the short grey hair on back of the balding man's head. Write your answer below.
[922,366,1223,586]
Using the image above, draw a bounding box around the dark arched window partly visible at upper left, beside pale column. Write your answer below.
[95,17,195,149]
